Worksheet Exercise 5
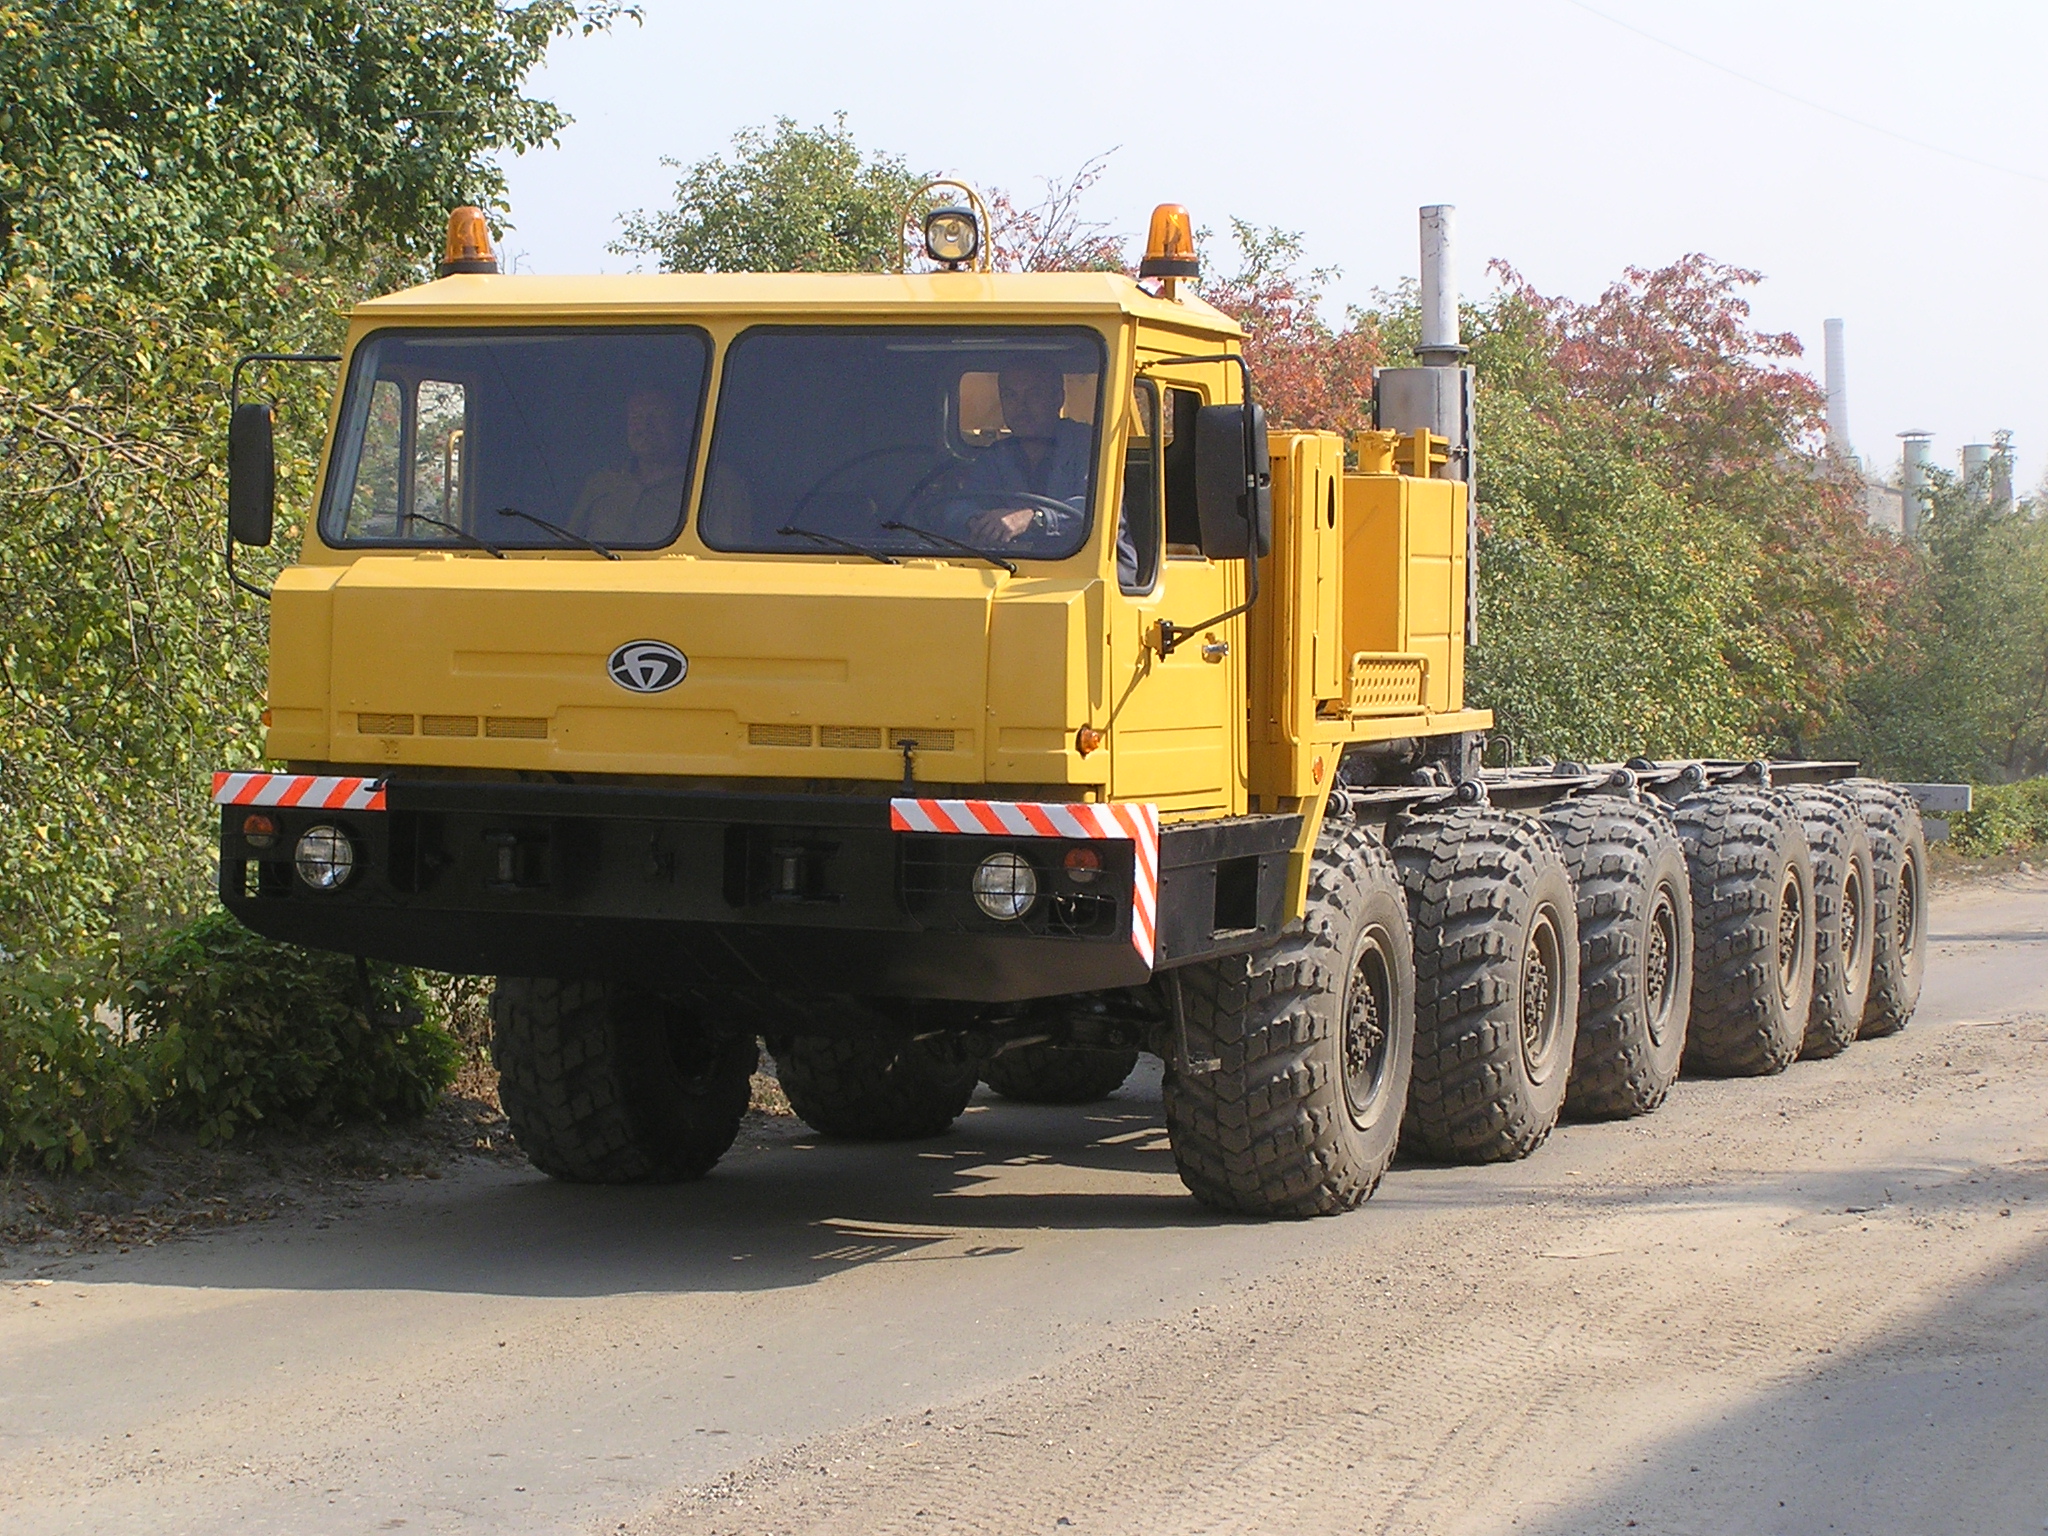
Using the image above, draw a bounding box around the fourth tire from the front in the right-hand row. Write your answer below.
[1671,788,1812,1077]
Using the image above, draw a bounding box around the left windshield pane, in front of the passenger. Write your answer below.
[319,328,709,549]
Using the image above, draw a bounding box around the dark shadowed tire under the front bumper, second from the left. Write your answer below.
[772,1024,981,1141]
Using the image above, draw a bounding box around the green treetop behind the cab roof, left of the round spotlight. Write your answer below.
[612,113,926,272]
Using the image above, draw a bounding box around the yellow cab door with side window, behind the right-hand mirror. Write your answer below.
[1110,381,1245,817]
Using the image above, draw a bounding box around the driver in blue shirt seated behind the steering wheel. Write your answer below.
[961,360,1096,545]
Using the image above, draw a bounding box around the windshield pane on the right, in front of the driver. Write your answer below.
[698,326,1102,563]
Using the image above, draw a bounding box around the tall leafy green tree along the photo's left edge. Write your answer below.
[0,0,618,978]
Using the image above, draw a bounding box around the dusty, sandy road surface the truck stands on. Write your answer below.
[0,879,2048,1536]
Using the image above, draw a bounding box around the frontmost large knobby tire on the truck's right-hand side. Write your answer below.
[1165,825,1415,1217]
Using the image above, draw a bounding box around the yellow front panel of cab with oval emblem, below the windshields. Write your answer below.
[266,553,1106,782]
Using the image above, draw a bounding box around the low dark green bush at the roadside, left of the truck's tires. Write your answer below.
[127,911,463,1143]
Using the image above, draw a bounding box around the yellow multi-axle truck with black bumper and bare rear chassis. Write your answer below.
[215,205,1925,1214]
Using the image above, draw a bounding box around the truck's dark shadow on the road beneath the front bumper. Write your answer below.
[94,1083,1227,1296]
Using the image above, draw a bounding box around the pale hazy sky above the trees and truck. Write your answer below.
[504,0,2048,485]
